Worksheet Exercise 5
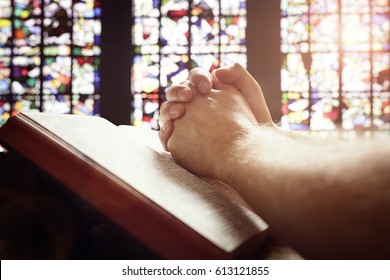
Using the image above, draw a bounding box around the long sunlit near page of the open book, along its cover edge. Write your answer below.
[28,114,268,252]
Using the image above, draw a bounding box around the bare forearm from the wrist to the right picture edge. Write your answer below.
[221,127,390,257]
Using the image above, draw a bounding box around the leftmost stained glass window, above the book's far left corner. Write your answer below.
[0,0,101,125]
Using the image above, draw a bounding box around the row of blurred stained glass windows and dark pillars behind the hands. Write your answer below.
[0,0,390,132]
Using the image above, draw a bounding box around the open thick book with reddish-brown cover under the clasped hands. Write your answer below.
[0,113,269,259]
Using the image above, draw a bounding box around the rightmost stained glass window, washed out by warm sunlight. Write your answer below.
[281,0,390,131]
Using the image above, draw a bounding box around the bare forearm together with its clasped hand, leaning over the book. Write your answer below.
[160,64,390,259]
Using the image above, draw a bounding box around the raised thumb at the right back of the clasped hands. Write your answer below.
[214,63,272,123]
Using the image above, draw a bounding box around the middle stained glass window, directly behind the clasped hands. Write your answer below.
[131,0,247,129]
